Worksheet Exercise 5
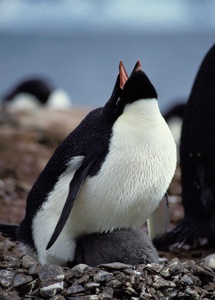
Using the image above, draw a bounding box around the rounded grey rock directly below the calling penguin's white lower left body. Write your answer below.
[38,264,65,281]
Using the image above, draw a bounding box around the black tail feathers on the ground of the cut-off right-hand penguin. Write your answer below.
[153,220,215,251]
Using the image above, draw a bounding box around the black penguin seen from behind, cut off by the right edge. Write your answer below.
[154,45,215,248]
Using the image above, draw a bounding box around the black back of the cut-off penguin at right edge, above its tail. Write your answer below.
[180,45,215,219]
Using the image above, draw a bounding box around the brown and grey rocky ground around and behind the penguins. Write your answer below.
[0,108,215,300]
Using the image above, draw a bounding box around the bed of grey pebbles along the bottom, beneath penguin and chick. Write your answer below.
[0,255,215,300]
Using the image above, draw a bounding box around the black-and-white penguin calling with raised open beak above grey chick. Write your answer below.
[0,62,176,265]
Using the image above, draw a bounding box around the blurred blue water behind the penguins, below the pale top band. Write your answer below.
[0,32,215,112]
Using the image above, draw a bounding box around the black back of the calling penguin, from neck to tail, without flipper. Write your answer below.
[17,108,115,247]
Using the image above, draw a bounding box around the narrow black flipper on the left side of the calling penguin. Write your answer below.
[46,157,96,250]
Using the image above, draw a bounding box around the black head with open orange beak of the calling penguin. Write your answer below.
[103,61,157,119]
